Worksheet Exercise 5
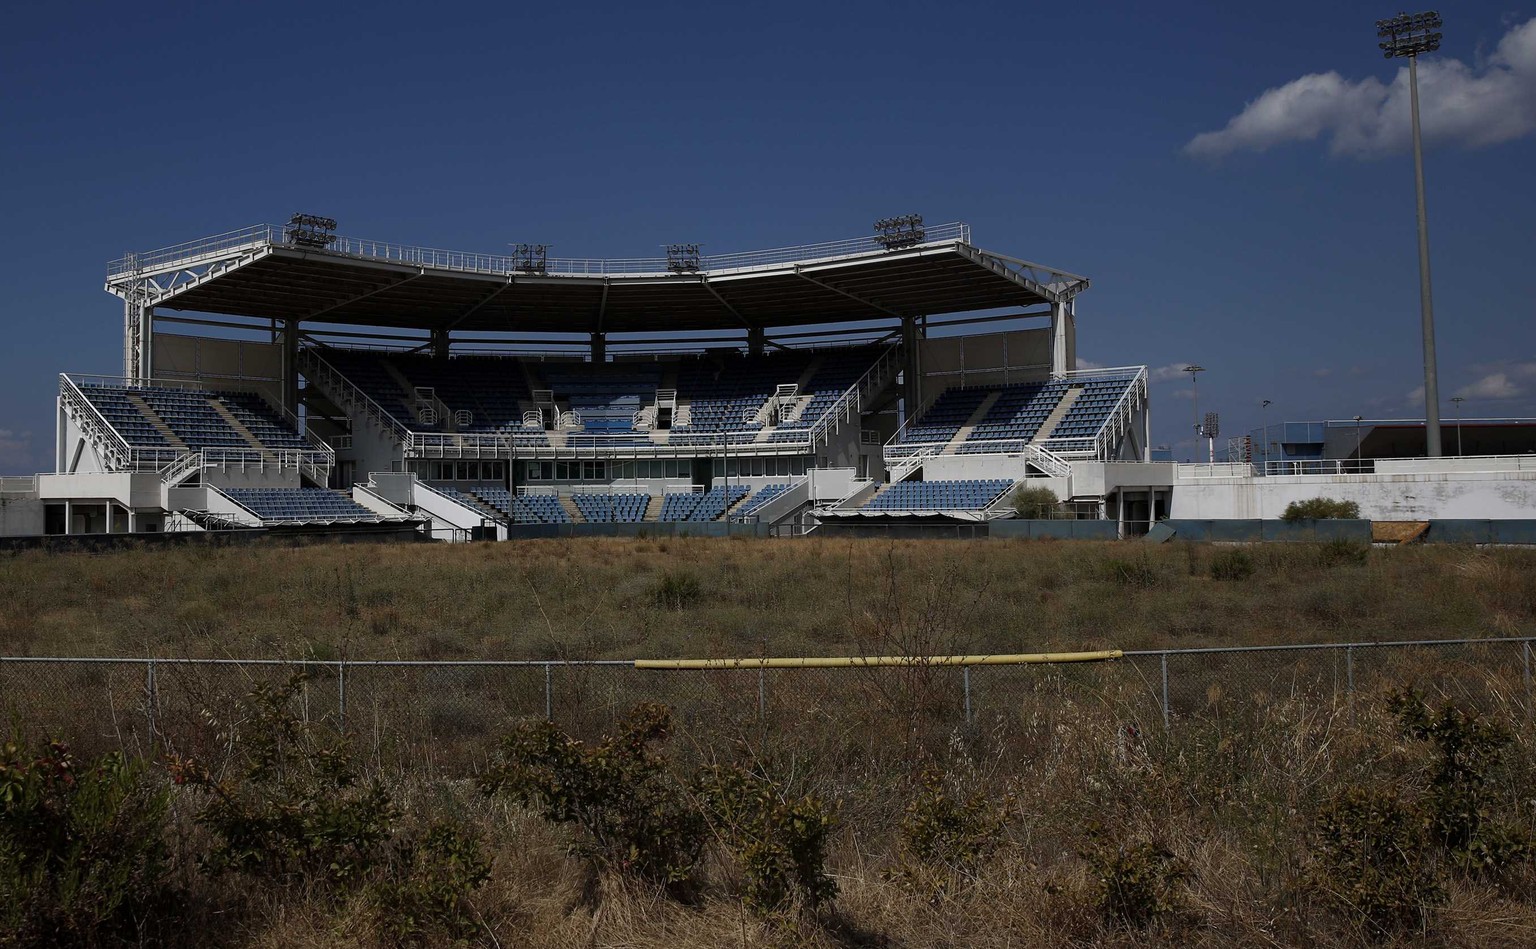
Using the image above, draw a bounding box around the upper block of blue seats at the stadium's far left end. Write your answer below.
[80,384,313,450]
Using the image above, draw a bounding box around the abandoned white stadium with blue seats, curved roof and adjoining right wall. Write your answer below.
[0,213,1536,541]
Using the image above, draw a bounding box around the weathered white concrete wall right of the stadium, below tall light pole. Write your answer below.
[1170,471,1536,521]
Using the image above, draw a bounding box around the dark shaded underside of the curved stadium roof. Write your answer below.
[155,244,1049,333]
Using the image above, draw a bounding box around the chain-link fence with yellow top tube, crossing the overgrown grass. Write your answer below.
[0,639,1533,772]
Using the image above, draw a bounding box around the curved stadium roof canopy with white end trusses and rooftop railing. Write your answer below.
[106,224,1089,333]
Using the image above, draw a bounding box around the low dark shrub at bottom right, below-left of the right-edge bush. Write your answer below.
[1307,786,1445,935]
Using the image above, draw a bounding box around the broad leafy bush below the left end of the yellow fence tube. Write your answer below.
[481,703,705,891]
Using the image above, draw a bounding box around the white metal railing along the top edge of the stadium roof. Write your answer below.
[108,221,971,281]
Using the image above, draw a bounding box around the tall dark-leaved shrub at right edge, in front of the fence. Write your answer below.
[1390,691,1533,874]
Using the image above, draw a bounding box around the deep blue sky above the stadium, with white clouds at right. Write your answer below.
[0,2,1536,473]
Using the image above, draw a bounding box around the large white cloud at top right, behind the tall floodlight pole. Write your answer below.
[1184,18,1536,158]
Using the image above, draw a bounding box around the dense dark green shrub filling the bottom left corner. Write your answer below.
[0,737,174,946]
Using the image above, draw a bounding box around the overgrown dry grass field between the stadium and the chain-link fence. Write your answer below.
[0,539,1536,659]
